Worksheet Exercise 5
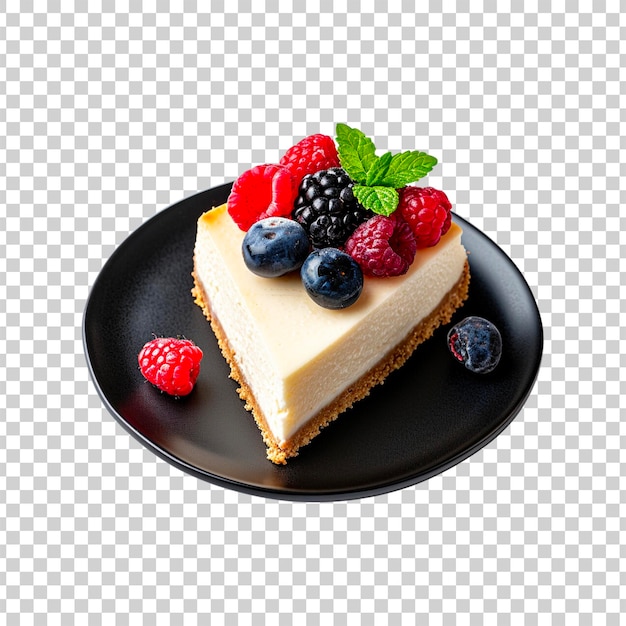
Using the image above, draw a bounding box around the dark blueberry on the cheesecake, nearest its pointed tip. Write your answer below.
[300,248,363,309]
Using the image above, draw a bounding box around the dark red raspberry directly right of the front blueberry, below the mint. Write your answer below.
[345,213,417,277]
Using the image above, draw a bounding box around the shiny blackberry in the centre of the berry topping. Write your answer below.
[291,167,373,248]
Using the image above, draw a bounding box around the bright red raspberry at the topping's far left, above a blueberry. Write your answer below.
[228,164,298,231]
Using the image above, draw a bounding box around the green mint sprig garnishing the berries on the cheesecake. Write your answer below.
[337,124,437,215]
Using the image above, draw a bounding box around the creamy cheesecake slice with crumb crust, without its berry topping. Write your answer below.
[193,204,469,464]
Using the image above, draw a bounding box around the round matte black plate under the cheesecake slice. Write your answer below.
[83,183,543,500]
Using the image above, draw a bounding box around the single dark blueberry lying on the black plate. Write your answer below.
[448,315,502,374]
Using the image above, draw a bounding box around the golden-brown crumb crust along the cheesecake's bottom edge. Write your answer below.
[191,260,470,465]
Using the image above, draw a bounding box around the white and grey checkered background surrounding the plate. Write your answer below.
[0,0,626,626]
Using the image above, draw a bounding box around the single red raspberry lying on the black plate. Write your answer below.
[137,337,202,396]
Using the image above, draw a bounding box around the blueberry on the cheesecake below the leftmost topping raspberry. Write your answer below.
[241,217,310,278]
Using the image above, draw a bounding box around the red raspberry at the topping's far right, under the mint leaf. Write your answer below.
[397,186,452,248]
